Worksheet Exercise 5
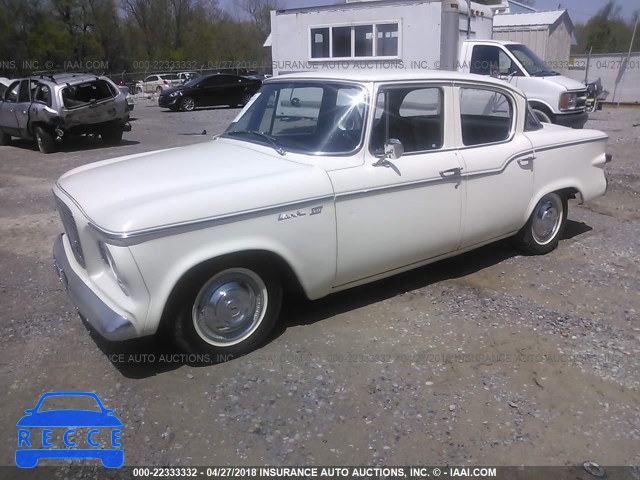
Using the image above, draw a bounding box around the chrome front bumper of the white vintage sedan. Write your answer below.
[53,235,138,341]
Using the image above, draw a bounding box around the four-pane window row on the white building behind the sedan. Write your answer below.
[311,22,400,59]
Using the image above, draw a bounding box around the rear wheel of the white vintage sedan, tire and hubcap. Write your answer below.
[514,192,568,255]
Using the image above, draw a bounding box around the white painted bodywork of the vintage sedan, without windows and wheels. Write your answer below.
[54,71,607,339]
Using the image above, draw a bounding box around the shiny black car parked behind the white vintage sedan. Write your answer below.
[158,73,262,112]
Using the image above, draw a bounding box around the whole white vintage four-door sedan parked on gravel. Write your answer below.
[54,71,610,358]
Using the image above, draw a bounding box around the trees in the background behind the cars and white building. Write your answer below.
[0,0,640,77]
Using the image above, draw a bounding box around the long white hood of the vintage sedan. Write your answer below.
[54,139,333,233]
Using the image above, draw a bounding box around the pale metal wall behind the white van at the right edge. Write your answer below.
[566,52,640,103]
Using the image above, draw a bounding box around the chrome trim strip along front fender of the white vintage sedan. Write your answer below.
[89,195,334,246]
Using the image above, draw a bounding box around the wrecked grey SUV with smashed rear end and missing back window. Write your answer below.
[0,73,131,153]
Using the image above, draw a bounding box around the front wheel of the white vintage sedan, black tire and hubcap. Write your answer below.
[174,261,282,363]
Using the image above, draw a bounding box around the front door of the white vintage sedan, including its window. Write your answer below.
[329,84,463,288]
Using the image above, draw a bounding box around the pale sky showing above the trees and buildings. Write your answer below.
[220,0,640,23]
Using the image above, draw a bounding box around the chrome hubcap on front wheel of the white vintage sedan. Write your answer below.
[193,268,267,346]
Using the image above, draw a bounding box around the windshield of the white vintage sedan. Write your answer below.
[224,82,367,155]
